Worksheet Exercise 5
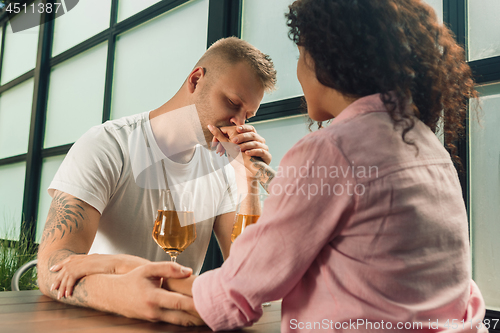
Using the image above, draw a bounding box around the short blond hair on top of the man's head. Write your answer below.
[195,37,276,92]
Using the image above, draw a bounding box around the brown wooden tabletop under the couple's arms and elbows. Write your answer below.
[0,290,281,333]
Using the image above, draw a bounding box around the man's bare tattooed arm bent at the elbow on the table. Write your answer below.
[38,191,203,326]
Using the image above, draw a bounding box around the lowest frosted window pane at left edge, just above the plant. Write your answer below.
[0,162,26,240]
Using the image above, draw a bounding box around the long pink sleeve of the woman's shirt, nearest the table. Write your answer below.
[193,133,355,331]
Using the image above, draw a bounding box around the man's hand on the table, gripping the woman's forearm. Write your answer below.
[106,262,204,326]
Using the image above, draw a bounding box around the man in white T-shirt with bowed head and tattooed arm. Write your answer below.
[38,38,276,324]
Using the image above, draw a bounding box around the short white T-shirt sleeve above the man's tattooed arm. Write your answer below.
[48,125,123,214]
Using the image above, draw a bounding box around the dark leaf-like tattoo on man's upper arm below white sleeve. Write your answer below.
[40,192,87,248]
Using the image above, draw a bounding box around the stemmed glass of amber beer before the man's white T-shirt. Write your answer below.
[153,190,196,262]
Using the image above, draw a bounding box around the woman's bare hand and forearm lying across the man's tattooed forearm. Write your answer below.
[50,254,150,299]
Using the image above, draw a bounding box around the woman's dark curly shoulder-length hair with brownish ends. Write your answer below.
[285,0,477,165]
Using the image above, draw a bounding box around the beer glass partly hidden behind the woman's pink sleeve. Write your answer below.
[231,193,267,242]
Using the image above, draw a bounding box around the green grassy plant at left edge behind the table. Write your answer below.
[0,223,38,291]
